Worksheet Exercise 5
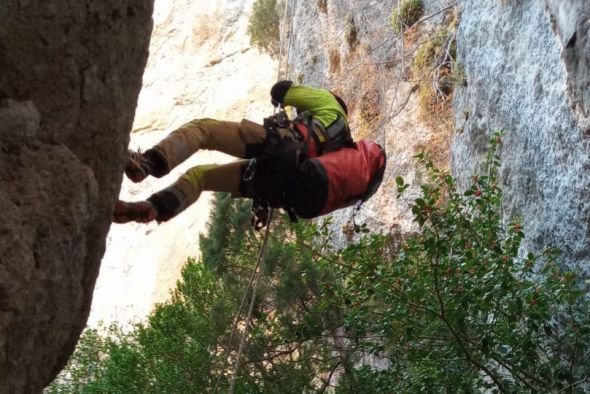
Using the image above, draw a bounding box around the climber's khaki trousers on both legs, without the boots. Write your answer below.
[149,119,266,220]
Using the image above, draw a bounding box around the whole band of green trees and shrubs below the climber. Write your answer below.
[48,135,590,393]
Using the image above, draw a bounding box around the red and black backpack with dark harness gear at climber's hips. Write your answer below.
[246,113,386,222]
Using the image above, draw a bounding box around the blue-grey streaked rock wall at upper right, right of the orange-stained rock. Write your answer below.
[452,0,590,274]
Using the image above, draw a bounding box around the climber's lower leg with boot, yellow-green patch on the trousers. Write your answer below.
[113,160,248,223]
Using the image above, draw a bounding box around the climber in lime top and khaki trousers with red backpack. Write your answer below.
[113,81,385,223]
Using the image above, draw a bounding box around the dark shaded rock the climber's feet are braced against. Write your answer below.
[0,0,152,393]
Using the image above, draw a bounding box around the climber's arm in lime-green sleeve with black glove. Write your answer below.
[270,81,347,127]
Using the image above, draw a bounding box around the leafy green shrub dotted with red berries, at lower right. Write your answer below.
[332,134,590,393]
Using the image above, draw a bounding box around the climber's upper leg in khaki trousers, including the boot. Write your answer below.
[125,119,266,182]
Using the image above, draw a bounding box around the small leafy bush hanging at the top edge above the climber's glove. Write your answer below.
[248,0,285,58]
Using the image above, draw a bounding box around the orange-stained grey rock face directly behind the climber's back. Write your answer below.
[282,0,453,245]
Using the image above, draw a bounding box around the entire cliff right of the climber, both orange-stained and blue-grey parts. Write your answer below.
[287,0,590,275]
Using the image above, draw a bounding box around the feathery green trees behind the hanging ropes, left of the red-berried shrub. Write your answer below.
[50,194,350,393]
